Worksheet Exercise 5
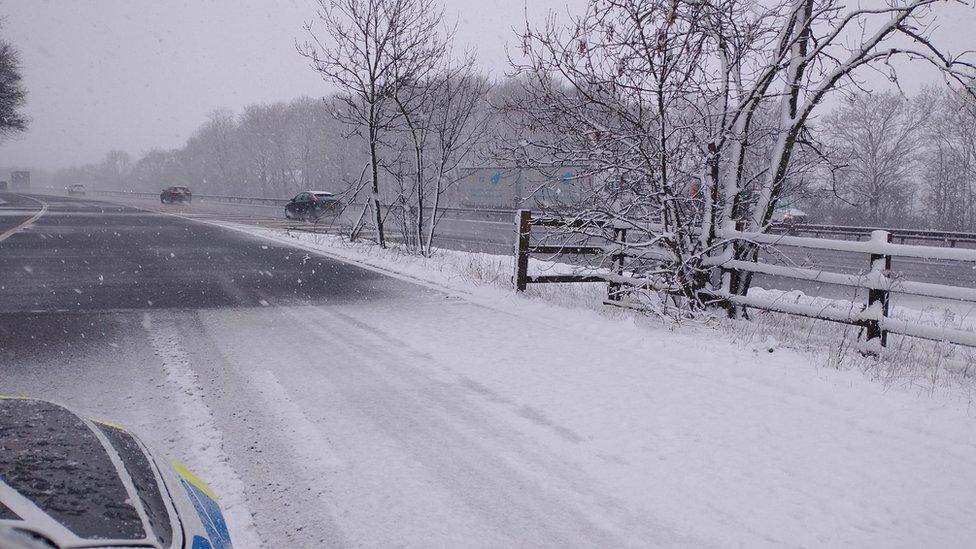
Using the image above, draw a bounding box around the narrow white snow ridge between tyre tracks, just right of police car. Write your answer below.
[142,312,263,548]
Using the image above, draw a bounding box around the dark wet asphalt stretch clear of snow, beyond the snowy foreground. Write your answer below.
[0,194,412,314]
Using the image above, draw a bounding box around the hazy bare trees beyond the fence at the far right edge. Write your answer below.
[794,88,976,231]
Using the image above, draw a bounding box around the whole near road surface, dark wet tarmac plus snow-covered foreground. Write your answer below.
[0,197,976,547]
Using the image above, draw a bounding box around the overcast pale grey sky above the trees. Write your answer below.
[0,0,976,168]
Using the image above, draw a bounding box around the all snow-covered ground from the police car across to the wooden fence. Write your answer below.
[5,215,976,547]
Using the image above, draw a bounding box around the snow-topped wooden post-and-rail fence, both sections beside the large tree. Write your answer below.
[513,210,976,347]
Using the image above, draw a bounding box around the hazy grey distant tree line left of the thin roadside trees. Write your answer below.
[44,98,363,197]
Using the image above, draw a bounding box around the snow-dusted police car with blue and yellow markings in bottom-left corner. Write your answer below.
[0,396,231,549]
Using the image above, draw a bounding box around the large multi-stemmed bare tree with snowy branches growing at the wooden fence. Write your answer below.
[514,0,976,304]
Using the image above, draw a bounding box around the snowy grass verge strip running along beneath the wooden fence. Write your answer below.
[215,220,976,394]
